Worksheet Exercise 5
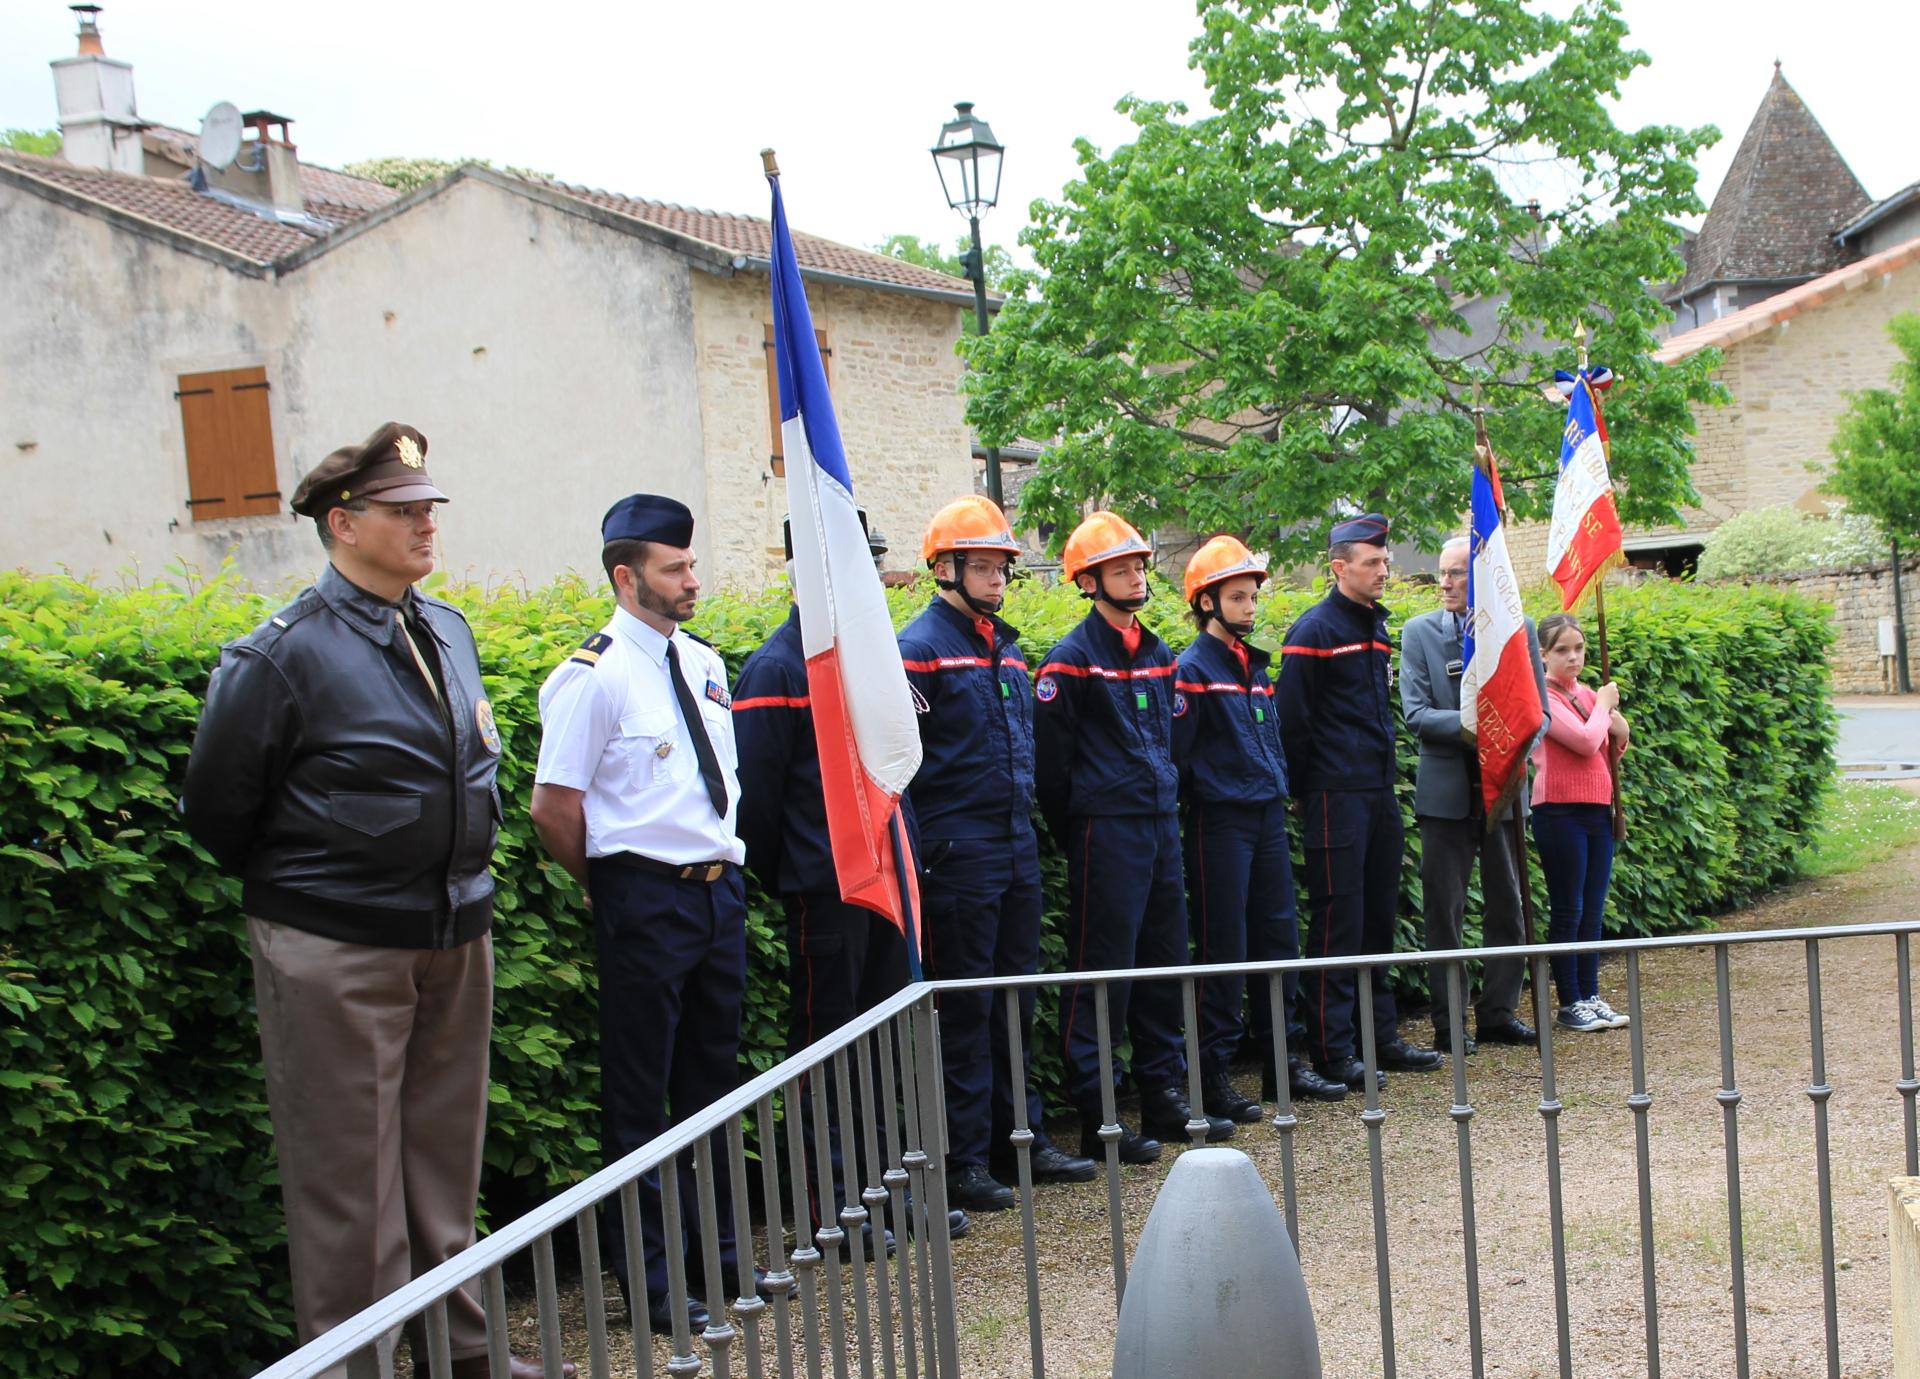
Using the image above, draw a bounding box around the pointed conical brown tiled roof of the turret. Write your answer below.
[1674,63,1872,298]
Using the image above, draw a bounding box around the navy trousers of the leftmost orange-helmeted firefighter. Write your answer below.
[920,828,1046,1166]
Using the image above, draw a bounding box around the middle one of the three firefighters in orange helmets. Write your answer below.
[1033,511,1233,1164]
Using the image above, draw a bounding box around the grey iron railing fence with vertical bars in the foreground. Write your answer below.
[257,922,1920,1379]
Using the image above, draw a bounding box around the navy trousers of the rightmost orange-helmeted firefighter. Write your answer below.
[1185,799,1306,1074]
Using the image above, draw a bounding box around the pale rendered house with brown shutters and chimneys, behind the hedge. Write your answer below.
[0,17,973,588]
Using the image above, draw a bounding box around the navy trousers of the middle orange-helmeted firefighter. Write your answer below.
[1060,814,1187,1114]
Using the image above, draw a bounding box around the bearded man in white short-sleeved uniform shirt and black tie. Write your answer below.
[532,494,747,1331]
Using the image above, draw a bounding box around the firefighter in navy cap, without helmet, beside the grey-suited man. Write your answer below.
[1275,513,1440,1089]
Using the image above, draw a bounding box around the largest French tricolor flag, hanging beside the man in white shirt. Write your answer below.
[766,175,920,967]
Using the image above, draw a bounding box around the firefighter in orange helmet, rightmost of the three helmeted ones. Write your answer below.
[1173,536,1346,1124]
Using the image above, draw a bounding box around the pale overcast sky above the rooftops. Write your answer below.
[0,0,1920,259]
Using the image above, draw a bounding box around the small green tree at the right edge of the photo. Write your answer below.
[1824,311,1920,693]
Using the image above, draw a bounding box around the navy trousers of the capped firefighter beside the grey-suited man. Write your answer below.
[1300,787,1405,1066]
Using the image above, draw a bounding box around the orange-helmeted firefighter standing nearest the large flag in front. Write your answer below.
[900,496,1094,1212]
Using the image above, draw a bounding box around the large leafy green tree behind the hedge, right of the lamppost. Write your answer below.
[962,0,1718,559]
